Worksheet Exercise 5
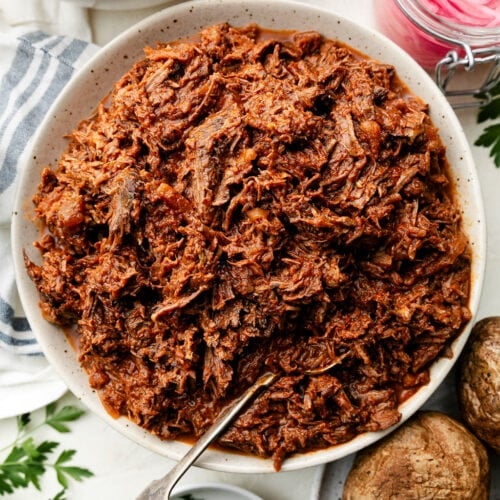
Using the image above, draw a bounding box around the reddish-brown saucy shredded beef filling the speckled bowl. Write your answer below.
[26,24,470,469]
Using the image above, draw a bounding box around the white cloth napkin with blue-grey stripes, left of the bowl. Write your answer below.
[0,0,98,418]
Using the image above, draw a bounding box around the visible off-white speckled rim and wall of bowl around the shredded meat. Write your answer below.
[12,0,486,473]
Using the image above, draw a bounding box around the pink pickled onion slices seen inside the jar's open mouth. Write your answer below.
[420,0,500,28]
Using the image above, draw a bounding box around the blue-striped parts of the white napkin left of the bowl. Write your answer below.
[0,31,94,356]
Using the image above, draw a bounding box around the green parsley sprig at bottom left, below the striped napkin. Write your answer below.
[0,403,93,500]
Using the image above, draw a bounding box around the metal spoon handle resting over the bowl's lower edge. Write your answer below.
[137,373,278,500]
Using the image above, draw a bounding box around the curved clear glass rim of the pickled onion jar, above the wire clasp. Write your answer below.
[395,0,500,47]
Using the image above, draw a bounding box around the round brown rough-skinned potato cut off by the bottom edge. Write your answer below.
[342,412,489,500]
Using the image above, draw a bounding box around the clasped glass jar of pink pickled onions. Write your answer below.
[374,0,500,107]
